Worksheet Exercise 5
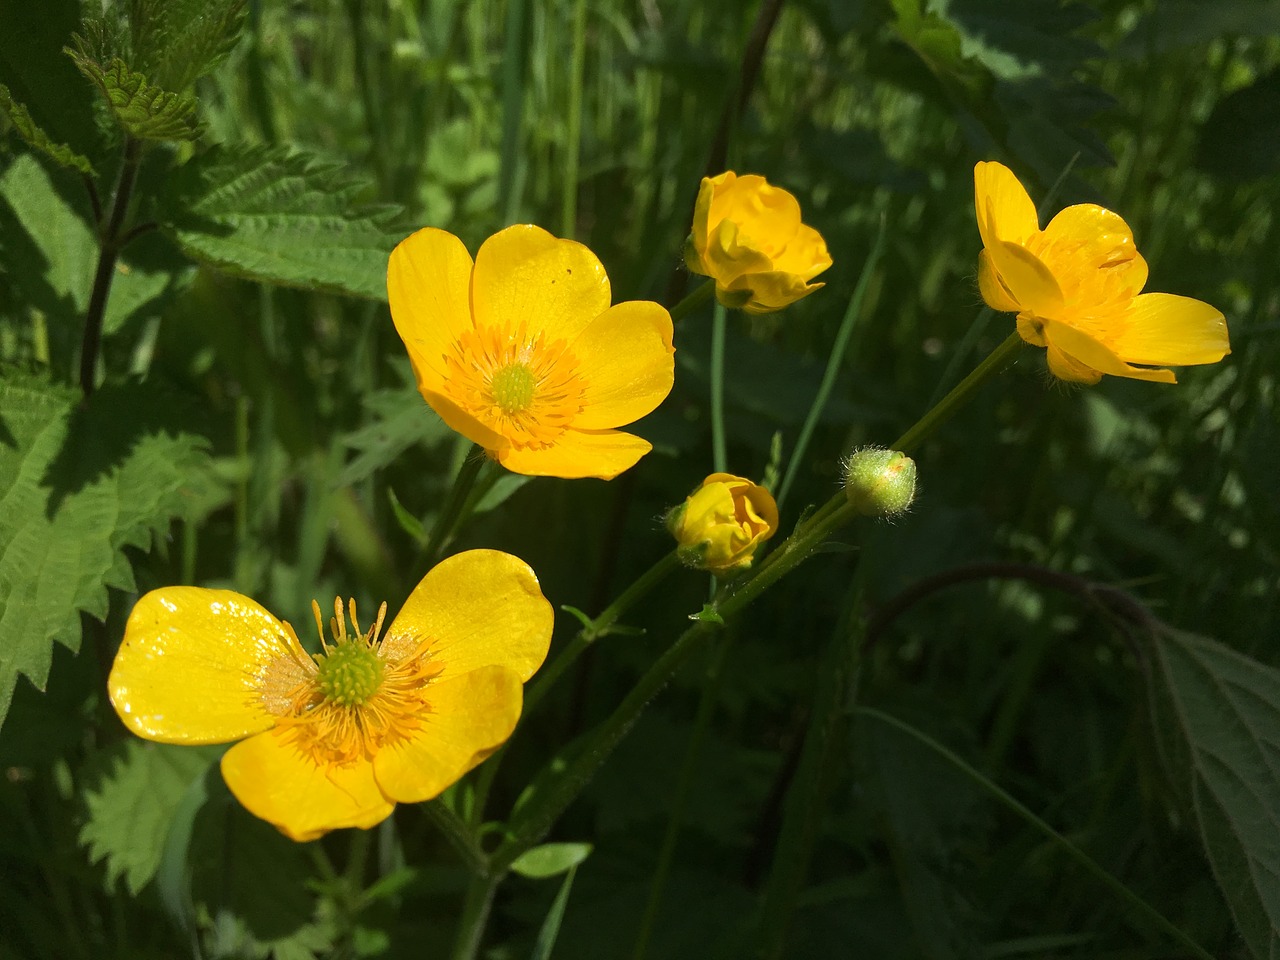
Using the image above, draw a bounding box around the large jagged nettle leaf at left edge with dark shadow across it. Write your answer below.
[0,374,207,723]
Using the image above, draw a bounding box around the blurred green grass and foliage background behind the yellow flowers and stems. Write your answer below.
[0,0,1280,960]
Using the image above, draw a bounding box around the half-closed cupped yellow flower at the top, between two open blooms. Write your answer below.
[685,170,831,314]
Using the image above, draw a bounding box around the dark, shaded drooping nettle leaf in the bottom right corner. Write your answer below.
[1153,630,1280,960]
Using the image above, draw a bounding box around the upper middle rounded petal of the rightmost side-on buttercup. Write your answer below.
[1033,204,1147,302]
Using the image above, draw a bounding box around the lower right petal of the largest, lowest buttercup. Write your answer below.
[374,667,524,804]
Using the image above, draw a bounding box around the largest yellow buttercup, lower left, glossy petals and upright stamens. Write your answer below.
[108,550,552,841]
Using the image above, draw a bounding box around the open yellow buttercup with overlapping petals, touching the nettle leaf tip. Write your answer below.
[387,225,675,479]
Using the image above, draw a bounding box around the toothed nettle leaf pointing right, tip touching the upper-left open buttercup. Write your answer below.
[164,148,407,301]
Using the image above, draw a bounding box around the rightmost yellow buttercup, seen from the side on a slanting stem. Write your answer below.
[973,161,1231,383]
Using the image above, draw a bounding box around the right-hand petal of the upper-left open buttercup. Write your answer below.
[572,301,676,430]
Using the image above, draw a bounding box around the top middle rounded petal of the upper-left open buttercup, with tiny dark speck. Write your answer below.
[471,224,611,342]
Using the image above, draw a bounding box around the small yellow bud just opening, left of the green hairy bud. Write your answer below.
[667,474,778,576]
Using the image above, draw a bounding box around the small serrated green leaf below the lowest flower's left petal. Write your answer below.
[79,740,218,896]
